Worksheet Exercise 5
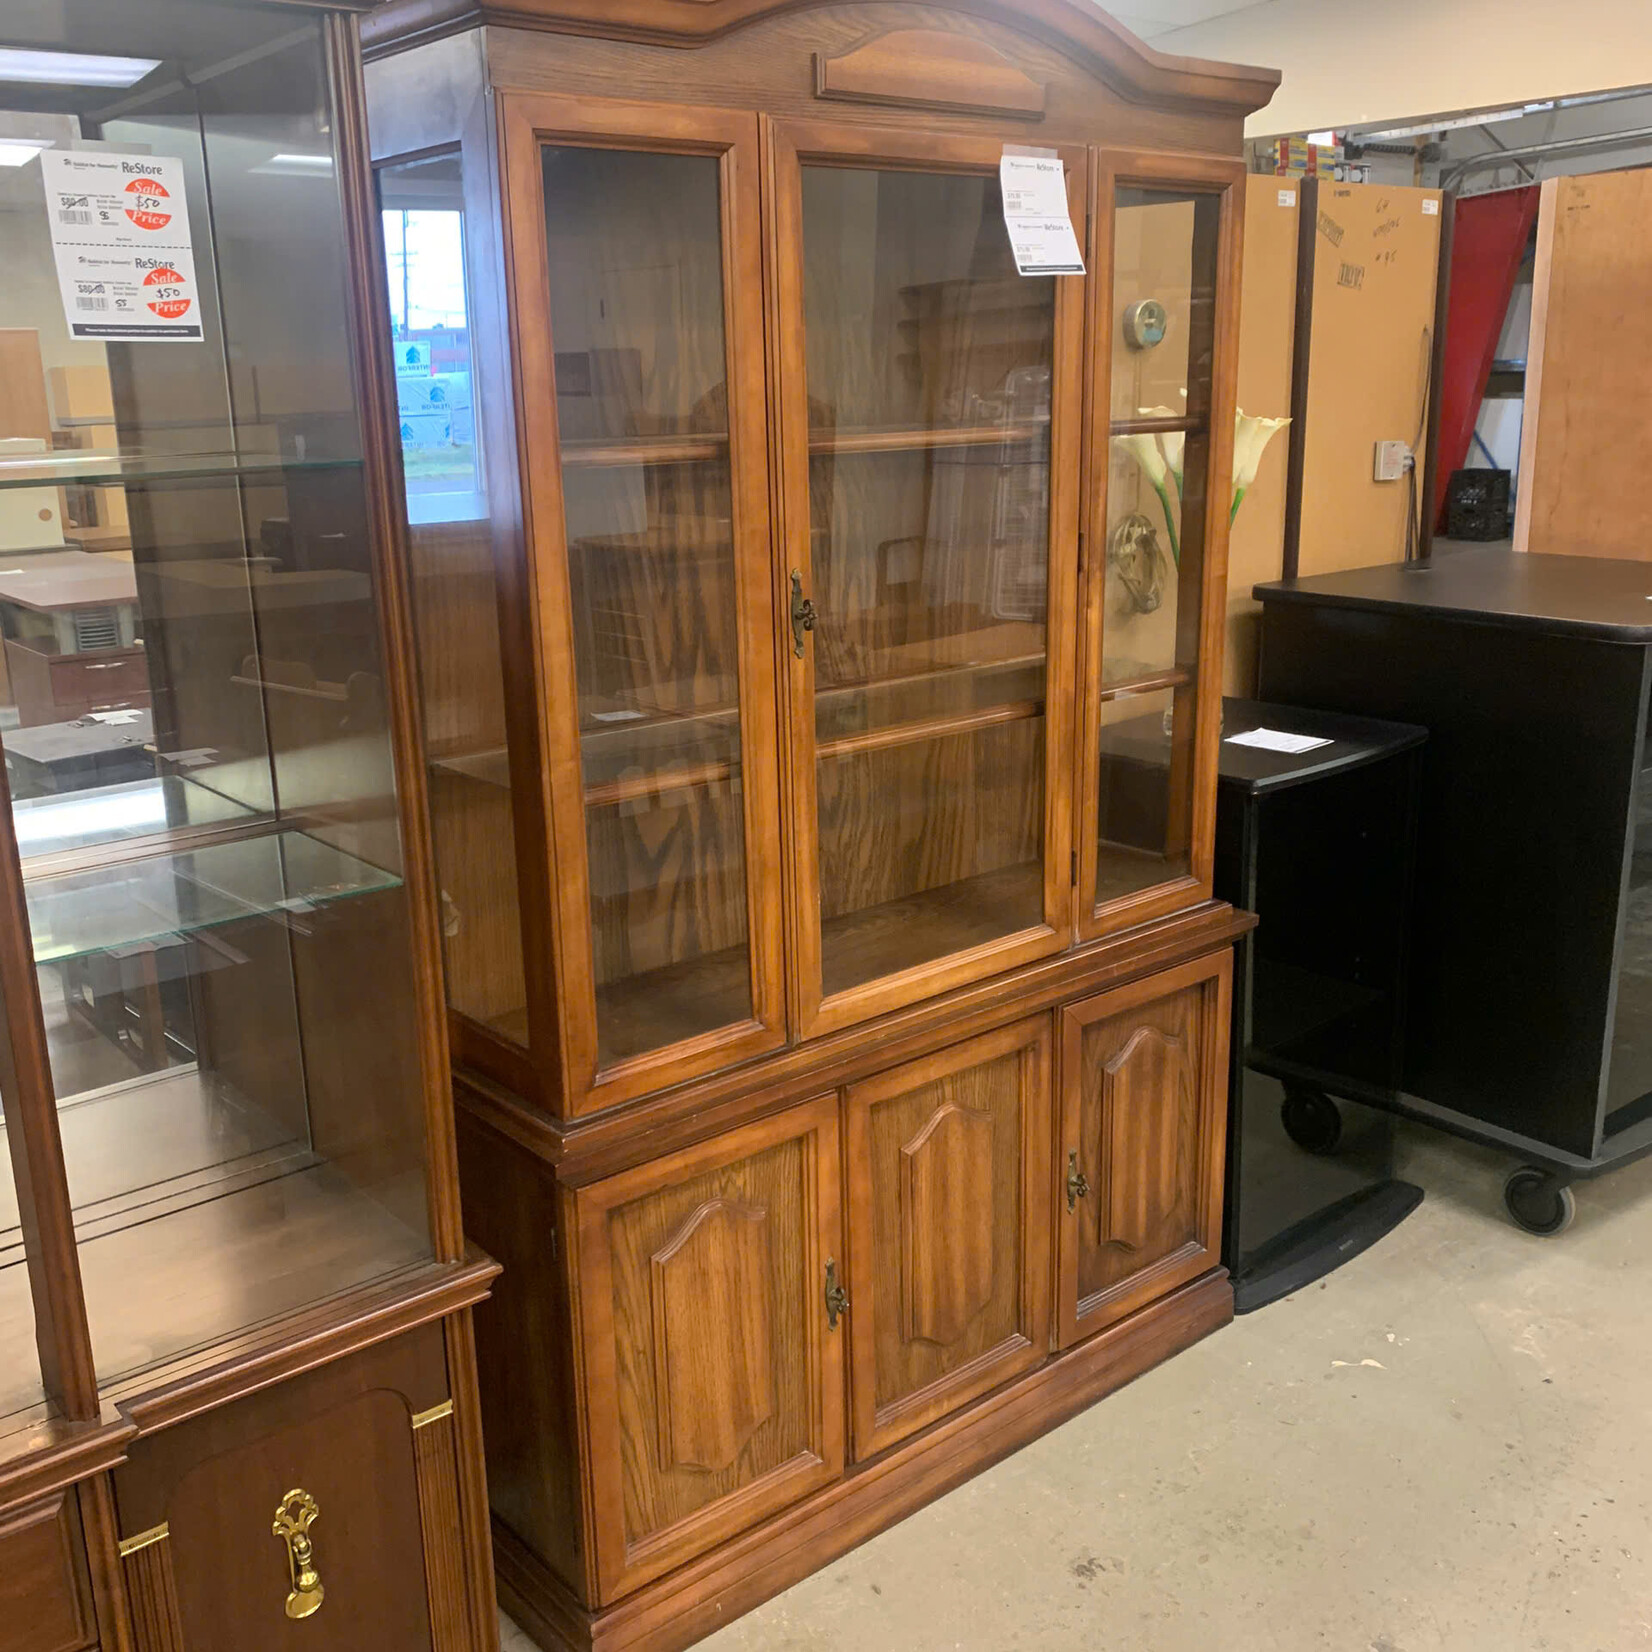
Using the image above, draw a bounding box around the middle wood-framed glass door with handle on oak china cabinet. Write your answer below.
[776,122,1084,1034]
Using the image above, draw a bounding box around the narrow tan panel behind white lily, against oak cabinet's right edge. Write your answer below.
[1222,177,1302,695]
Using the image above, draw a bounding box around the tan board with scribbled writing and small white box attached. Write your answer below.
[1300,183,1441,575]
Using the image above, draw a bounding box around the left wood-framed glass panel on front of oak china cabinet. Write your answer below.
[498,101,785,1112]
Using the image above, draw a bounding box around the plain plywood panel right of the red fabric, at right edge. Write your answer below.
[1515,172,1652,562]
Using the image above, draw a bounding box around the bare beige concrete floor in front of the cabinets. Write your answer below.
[506,1128,1652,1652]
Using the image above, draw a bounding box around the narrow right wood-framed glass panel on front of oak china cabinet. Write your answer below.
[1077,154,1242,935]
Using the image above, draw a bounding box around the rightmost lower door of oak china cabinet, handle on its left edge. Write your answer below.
[1056,952,1232,1346]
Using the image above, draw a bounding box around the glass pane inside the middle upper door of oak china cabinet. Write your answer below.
[803,165,1056,996]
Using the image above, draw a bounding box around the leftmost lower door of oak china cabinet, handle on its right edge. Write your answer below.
[572,1095,846,1604]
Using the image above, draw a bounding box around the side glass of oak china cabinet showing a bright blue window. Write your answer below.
[378,154,529,1046]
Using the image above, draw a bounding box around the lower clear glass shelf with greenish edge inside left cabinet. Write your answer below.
[28,831,401,963]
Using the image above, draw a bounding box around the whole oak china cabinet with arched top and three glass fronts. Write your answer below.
[363,0,1275,1649]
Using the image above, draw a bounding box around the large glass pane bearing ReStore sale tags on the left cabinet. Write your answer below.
[0,0,431,1386]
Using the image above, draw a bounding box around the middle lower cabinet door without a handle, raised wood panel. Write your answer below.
[846,1016,1051,1459]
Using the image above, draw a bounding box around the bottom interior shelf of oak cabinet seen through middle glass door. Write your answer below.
[821,861,1044,998]
